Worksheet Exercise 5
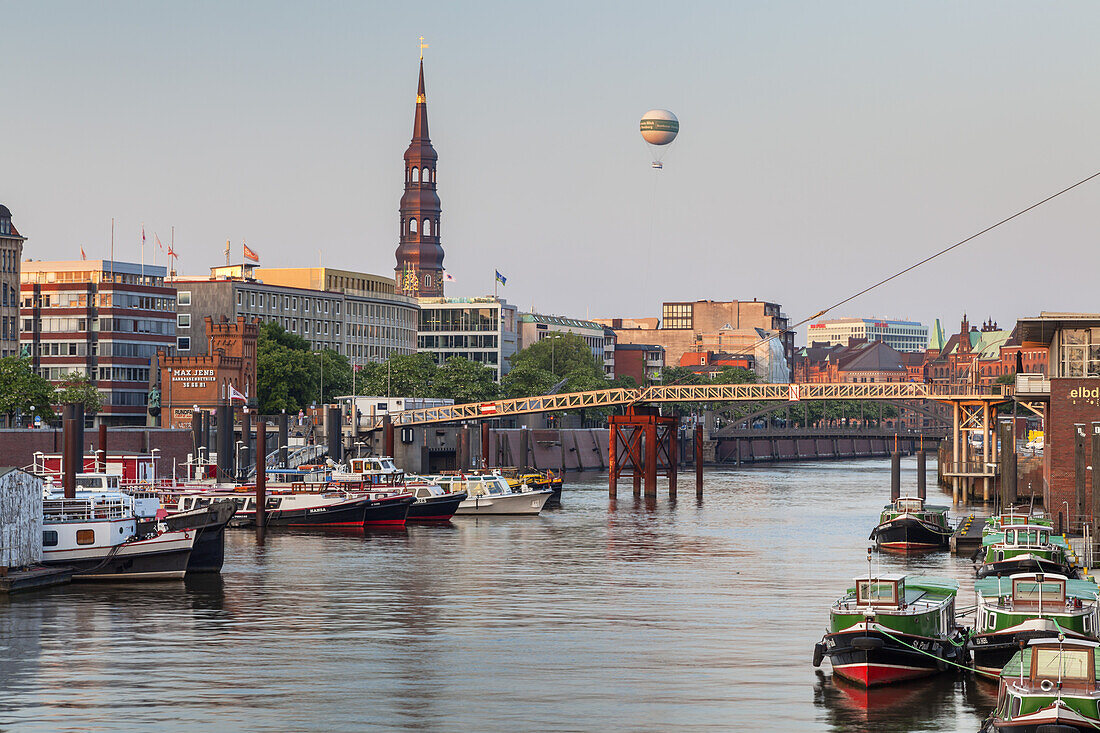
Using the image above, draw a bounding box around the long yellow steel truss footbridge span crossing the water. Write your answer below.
[364,382,1012,430]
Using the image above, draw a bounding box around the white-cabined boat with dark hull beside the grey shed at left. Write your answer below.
[42,489,197,580]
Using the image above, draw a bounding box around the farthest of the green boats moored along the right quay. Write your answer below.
[977,524,1078,579]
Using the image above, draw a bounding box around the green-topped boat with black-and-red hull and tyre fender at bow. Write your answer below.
[814,573,965,687]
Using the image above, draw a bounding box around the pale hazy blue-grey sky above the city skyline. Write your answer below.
[0,0,1100,342]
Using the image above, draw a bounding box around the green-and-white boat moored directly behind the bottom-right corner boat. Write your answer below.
[967,572,1100,672]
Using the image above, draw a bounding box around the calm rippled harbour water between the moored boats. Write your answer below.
[0,460,997,732]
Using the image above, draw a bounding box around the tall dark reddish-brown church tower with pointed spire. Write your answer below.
[394,53,443,297]
